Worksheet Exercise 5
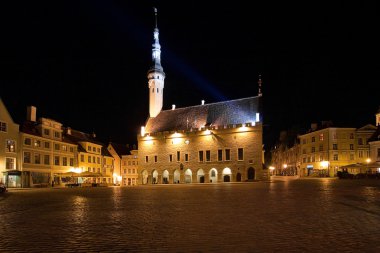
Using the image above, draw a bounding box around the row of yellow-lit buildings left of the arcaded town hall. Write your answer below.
[0,99,138,187]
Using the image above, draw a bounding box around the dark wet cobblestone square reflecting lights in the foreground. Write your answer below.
[0,179,380,252]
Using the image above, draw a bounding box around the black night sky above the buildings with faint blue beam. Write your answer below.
[0,0,380,147]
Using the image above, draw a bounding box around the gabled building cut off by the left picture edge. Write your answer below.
[0,98,21,187]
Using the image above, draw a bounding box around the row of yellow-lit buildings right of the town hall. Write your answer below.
[270,109,380,177]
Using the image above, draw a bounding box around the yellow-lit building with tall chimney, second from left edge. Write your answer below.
[19,106,77,187]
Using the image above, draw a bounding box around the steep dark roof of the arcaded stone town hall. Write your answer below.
[145,97,260,133]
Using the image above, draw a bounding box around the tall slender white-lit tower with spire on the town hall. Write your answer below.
[148,8,165,118]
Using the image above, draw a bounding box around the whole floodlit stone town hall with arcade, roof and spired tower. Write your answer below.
[138,10,268,184]
